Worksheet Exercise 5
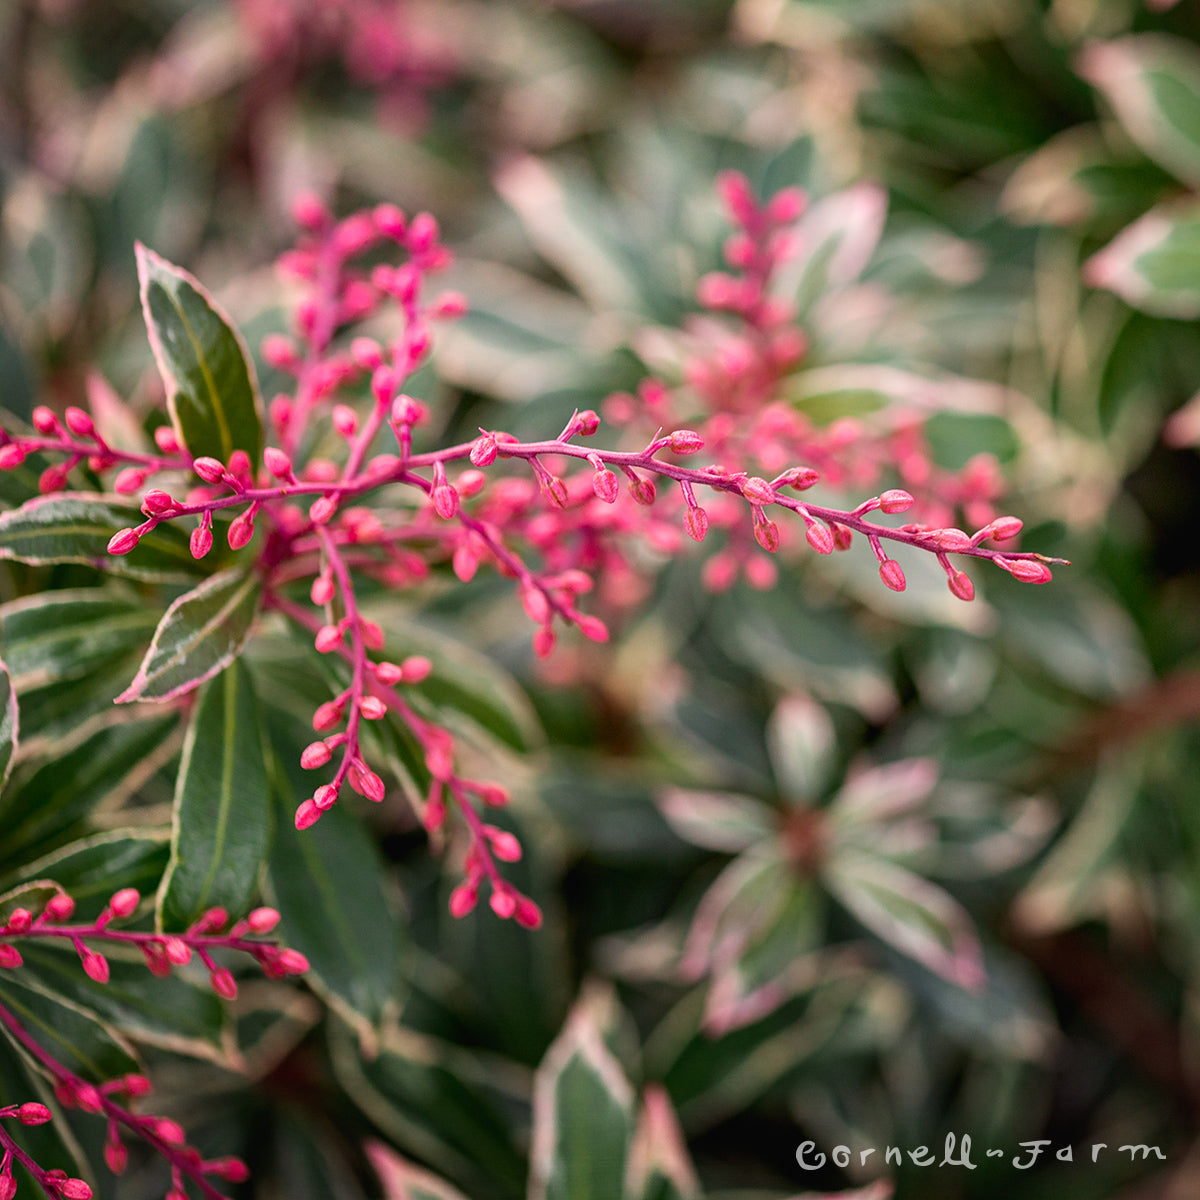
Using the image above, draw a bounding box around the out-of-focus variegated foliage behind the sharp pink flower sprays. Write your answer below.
[0,0,1200,1200]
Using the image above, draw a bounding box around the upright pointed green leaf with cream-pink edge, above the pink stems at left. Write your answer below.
[137,244,263,467]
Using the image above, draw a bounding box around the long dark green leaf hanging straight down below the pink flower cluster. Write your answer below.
[158,662,271,929]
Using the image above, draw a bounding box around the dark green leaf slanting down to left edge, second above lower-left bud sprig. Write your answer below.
[0,714,178,860]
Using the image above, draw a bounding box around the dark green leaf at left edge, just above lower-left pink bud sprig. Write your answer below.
[0,829,170,922]
